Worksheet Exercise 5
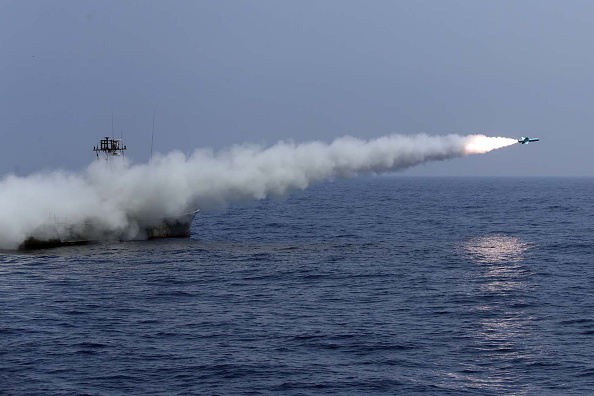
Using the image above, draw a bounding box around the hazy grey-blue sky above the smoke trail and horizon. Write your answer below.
[0,0,594,176]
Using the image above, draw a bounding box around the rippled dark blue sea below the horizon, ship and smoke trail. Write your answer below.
[0,177,594,395]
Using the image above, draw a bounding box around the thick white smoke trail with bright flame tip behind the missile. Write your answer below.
[0,135,516,249]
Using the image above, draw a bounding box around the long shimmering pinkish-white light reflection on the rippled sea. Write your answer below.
[450,234,538,395]
